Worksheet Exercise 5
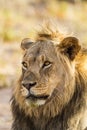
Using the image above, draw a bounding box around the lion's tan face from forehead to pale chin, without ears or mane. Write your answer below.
[22,42,63,105]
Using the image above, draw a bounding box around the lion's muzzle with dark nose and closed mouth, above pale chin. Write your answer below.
[22,81,49,100]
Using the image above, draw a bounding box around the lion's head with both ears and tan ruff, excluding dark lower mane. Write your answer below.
[15,24,80,116]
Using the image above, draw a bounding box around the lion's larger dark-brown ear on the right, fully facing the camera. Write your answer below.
[58,37,81,60]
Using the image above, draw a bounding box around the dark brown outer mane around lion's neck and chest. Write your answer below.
[12,70,87,130]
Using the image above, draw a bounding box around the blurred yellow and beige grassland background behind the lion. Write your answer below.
[0,0,87,130]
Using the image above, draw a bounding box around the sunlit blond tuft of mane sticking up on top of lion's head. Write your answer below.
[36,21,68,43]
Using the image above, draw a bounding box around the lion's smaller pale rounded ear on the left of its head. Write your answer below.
[21,38,34,50]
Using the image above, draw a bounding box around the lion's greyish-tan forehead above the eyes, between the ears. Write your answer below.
[24,42,56,59]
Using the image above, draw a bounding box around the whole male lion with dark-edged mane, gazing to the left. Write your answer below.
[11,23,87,130]
